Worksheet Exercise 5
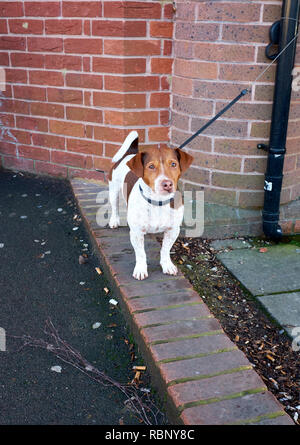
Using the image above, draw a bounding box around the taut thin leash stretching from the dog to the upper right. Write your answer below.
[179,21,300,149]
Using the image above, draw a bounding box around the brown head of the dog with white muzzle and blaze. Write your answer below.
[127,147,194,195]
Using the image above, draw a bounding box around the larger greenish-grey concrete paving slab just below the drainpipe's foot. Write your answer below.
[217,244,300,294]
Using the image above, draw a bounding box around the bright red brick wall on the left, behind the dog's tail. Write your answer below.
[0,0,173,178]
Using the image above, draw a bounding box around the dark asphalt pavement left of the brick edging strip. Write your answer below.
[0,170,155,425]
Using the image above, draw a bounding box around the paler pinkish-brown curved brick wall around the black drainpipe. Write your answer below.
[171,0,300,212]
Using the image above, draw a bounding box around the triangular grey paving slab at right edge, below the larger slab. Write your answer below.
[258,292,300,337]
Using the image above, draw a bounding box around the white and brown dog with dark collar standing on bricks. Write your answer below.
[109,131,193,280]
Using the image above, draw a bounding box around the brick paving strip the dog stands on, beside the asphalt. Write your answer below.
[71,179,294,425]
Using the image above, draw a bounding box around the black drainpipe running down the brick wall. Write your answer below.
[258,0,300,240]
